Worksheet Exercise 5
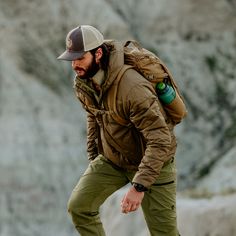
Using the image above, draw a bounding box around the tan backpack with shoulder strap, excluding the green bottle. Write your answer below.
[108,41,187,126]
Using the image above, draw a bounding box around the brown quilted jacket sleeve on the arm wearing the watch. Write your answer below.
[127,82,171,187]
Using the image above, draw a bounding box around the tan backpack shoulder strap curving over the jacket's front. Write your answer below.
[107,65,133,126]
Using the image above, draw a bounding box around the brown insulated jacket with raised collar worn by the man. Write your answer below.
[75,41,176,187]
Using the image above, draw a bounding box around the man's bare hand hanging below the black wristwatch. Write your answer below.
[121,186,144,214]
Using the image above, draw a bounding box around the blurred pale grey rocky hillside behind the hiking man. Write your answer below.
[0,0,236,236]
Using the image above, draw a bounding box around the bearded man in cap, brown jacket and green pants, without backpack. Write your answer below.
[58,25,179,236]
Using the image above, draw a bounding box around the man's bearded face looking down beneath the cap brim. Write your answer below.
[72,52,99,79]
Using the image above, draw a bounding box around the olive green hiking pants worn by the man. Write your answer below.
[68,155,179,236]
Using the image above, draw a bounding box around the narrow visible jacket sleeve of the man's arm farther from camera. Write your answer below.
[87,113,98,160]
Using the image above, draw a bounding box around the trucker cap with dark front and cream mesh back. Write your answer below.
[57,25,104,61]
